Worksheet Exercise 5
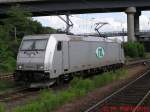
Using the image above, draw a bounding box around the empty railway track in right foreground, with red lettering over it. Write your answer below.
[85,70,150,112]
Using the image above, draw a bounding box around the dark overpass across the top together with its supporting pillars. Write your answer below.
[0,0,150,41]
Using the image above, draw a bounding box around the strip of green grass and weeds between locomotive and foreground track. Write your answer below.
[13,69,127,112]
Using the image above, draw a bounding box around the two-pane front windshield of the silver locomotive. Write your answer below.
[20,39,47,51]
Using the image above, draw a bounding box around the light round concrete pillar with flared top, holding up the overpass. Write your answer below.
[125,7,136,41]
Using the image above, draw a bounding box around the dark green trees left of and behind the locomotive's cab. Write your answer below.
[0,7,56,71]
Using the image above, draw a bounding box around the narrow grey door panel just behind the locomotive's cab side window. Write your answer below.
[62,41,69,72]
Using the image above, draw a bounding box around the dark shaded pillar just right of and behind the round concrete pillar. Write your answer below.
[134,11,141,34]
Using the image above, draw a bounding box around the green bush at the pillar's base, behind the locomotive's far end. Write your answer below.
[124,42,145,58]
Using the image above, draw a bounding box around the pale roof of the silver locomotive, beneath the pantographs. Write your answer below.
[24,34,120,43]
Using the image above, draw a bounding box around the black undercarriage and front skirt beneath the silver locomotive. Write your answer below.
[14,63,123,88]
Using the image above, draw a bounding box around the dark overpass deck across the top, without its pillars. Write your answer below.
[0,0,150,15]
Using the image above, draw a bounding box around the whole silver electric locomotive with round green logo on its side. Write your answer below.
[14,34,124,87]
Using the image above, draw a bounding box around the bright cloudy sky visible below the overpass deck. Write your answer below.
[34,11,150,34]
